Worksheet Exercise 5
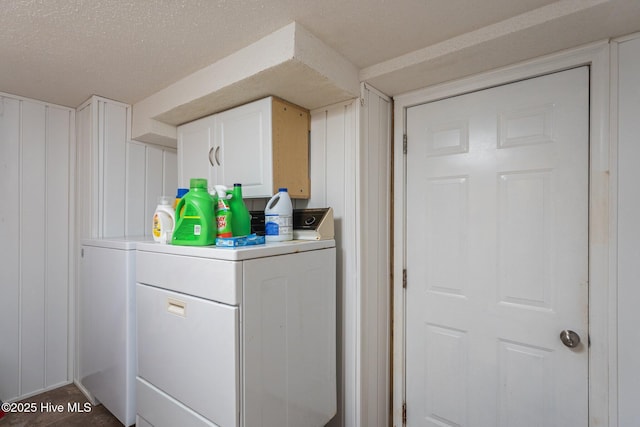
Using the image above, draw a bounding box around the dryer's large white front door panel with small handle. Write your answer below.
[136,283,240,426]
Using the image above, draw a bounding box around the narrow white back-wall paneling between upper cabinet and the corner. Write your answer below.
[295,100,360,426]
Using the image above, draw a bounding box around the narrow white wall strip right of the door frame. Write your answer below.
[612,34,640,427]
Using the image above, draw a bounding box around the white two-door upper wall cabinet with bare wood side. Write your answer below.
[178,97,311,199]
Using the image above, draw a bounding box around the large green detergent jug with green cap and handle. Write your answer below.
[171,178,216,246]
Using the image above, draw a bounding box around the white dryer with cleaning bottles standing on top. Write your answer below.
[136,240,337,427]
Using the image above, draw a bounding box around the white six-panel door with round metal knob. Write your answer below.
[405,67,589,427]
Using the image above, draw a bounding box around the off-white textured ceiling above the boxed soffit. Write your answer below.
[0,0,640,107]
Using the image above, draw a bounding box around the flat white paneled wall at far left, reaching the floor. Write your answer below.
[0,93,75,401]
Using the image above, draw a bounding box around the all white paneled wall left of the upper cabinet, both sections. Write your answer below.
[0,93,177,401]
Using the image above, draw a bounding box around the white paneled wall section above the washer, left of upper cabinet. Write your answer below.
[77,96,177,239]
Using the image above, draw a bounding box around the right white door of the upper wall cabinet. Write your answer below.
[215,98,273,197]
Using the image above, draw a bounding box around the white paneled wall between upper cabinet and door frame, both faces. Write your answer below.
[302,93,391,427]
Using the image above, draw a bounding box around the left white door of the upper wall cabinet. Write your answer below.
[178,116,220,188]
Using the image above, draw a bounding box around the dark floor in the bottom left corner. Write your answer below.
[0,384,122,427]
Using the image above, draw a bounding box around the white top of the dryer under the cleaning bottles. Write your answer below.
[136,240,336,261]
